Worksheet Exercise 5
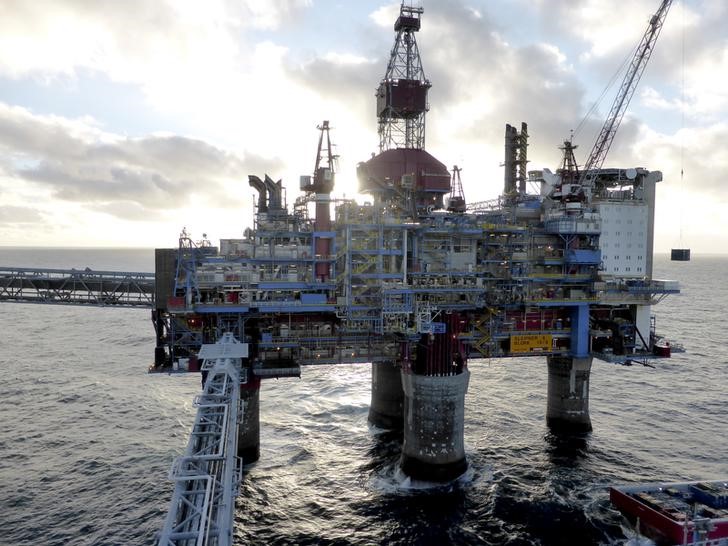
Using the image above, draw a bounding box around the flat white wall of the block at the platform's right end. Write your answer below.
[598,201,649,277]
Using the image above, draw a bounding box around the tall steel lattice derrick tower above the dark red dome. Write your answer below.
[377,3,430,152]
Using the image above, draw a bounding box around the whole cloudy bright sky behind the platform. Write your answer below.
[0,0,728,253]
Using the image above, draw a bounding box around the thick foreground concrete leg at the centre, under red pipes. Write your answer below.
[401,370,470,482]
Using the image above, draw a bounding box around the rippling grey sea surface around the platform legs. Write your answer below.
[0,248,728,545]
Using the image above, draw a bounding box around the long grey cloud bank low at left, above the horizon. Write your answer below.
[0,105,280,217]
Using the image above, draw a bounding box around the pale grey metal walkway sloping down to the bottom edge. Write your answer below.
[159,334,248,546]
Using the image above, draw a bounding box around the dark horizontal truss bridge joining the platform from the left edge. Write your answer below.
[0,267,154,308]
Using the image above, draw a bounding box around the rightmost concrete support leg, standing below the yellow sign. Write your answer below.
[546,356,592,432]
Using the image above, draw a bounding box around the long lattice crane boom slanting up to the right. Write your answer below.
[580,0,672,186]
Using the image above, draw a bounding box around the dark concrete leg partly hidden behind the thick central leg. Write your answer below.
[369,362,404,430]
